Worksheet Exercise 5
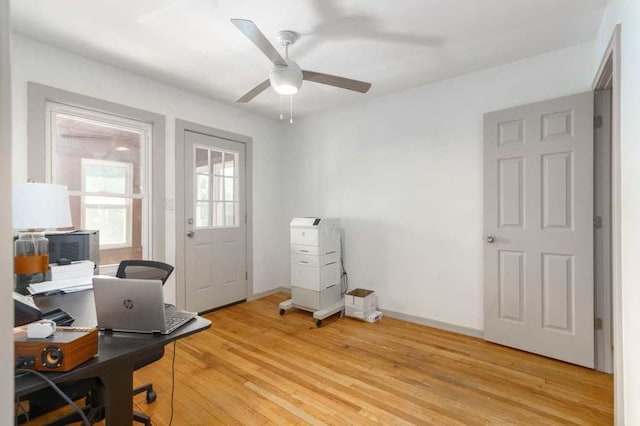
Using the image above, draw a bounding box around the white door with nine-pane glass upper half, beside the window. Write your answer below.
[184,130,247,312]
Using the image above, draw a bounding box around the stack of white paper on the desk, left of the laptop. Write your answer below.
[28,260,94,294]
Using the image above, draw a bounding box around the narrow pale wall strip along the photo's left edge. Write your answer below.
[0,0,13,425]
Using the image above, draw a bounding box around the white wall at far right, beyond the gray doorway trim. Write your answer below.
[593,0,640,425]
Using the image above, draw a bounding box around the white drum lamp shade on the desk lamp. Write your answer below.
[13,182,72,230]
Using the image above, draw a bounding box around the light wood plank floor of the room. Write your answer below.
[26,294,613,426]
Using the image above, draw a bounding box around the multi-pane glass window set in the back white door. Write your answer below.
[194,146,239,228]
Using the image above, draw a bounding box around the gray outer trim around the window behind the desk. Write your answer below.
[27,82,166,274]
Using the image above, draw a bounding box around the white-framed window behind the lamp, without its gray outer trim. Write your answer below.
[46,102,151,265]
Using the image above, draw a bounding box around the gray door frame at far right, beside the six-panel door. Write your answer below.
[592,24,624,424]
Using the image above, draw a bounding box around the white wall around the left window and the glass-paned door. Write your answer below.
[12,34,286,300]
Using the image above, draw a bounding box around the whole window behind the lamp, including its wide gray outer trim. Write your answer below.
[25,81,166,274]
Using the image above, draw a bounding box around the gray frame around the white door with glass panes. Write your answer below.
[175,118,253,309]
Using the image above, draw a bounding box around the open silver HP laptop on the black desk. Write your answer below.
[93,276,197,334]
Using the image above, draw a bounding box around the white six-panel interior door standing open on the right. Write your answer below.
[484,92,594,368]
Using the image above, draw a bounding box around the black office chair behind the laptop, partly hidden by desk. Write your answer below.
[116,260,173,424]
